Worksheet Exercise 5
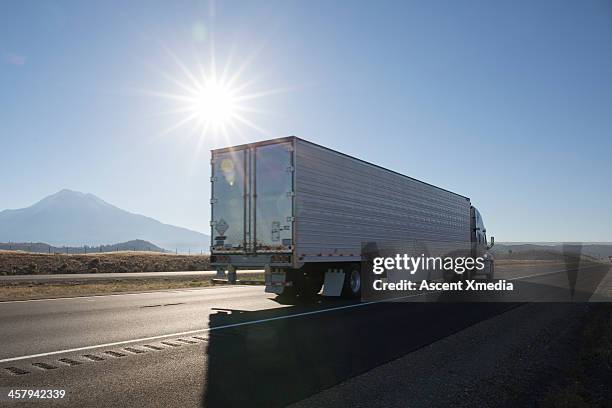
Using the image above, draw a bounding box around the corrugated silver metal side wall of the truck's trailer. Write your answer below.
[295,139,470,261]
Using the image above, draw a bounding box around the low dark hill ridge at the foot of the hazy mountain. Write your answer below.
[0,239,168,254]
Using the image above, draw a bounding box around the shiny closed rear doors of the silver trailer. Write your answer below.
[211,142,294,254]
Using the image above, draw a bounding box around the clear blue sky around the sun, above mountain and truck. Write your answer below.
[0,0,612,241]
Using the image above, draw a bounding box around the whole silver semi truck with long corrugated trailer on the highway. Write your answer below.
[211,136,493,297]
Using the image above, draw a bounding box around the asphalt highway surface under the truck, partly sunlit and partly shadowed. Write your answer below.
[0,267,607,407]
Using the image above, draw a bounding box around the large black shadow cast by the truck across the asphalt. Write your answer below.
[203,302,513,407]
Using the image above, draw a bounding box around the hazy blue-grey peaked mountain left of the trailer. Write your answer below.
[0,190,210,252]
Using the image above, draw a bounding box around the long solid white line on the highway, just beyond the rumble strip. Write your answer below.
[0,292,430,363]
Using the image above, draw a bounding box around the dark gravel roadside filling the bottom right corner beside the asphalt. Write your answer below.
[292,303,612,408]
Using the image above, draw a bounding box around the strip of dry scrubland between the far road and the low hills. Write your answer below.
[0,251,210,275]
